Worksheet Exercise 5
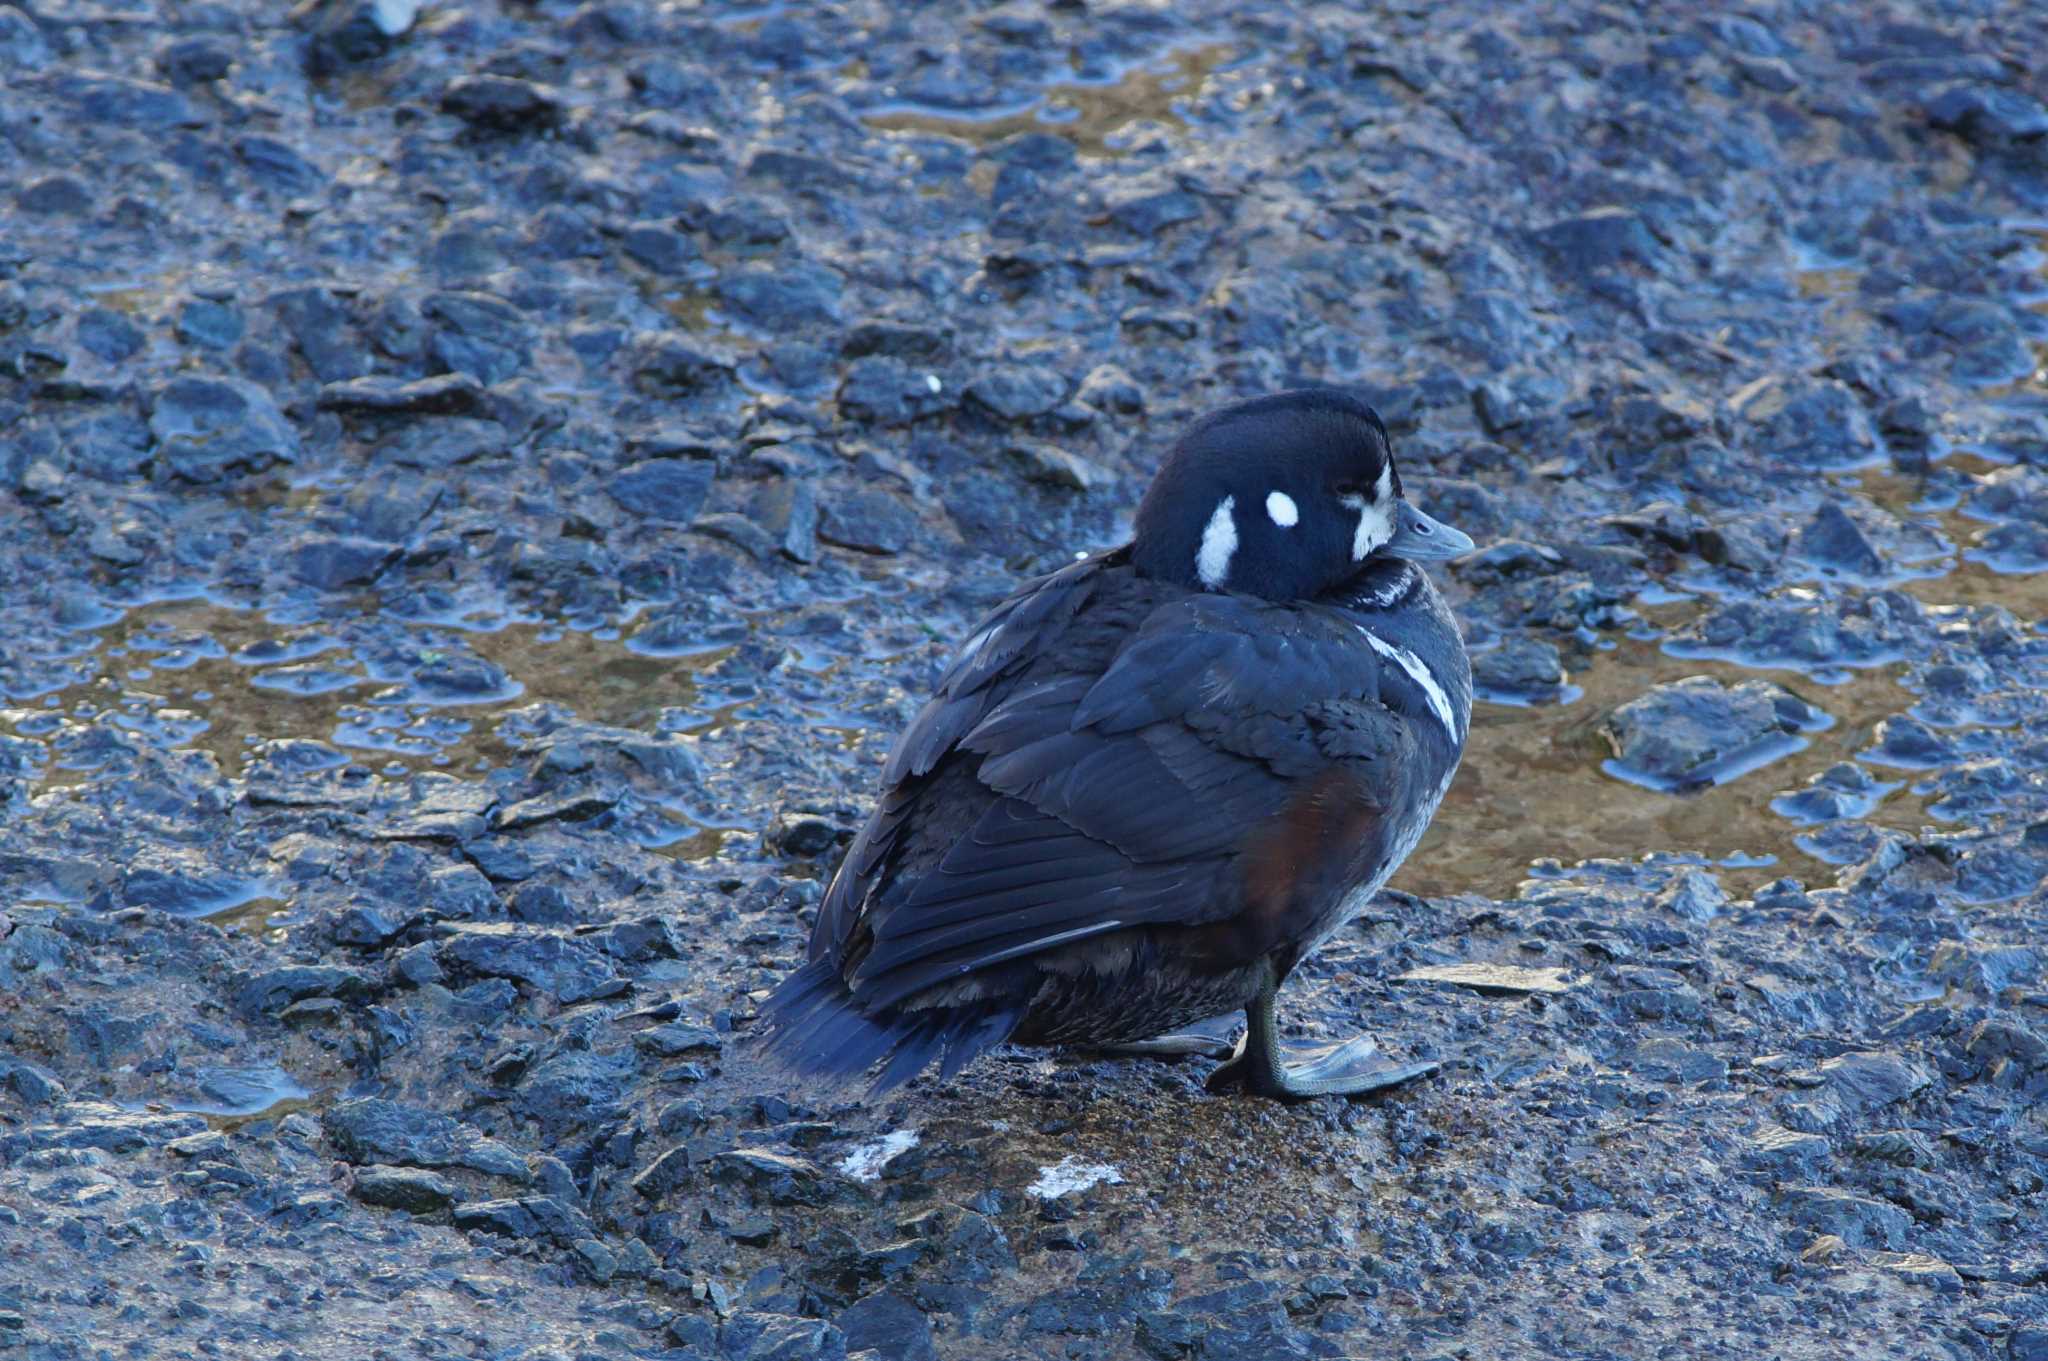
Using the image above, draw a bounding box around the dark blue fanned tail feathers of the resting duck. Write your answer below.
[754,960,1024,1099]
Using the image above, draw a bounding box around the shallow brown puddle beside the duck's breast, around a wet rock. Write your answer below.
[1393,639,1933,898]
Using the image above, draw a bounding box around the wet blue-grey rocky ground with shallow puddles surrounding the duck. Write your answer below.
[0,0,2048,1361]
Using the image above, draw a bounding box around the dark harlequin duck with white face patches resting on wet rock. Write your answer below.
[760,389,1473,1099]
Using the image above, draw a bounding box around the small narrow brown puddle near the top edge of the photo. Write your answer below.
[862,43,1237,156]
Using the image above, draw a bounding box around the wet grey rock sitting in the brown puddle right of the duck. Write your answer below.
[1602,675,1817,792]
